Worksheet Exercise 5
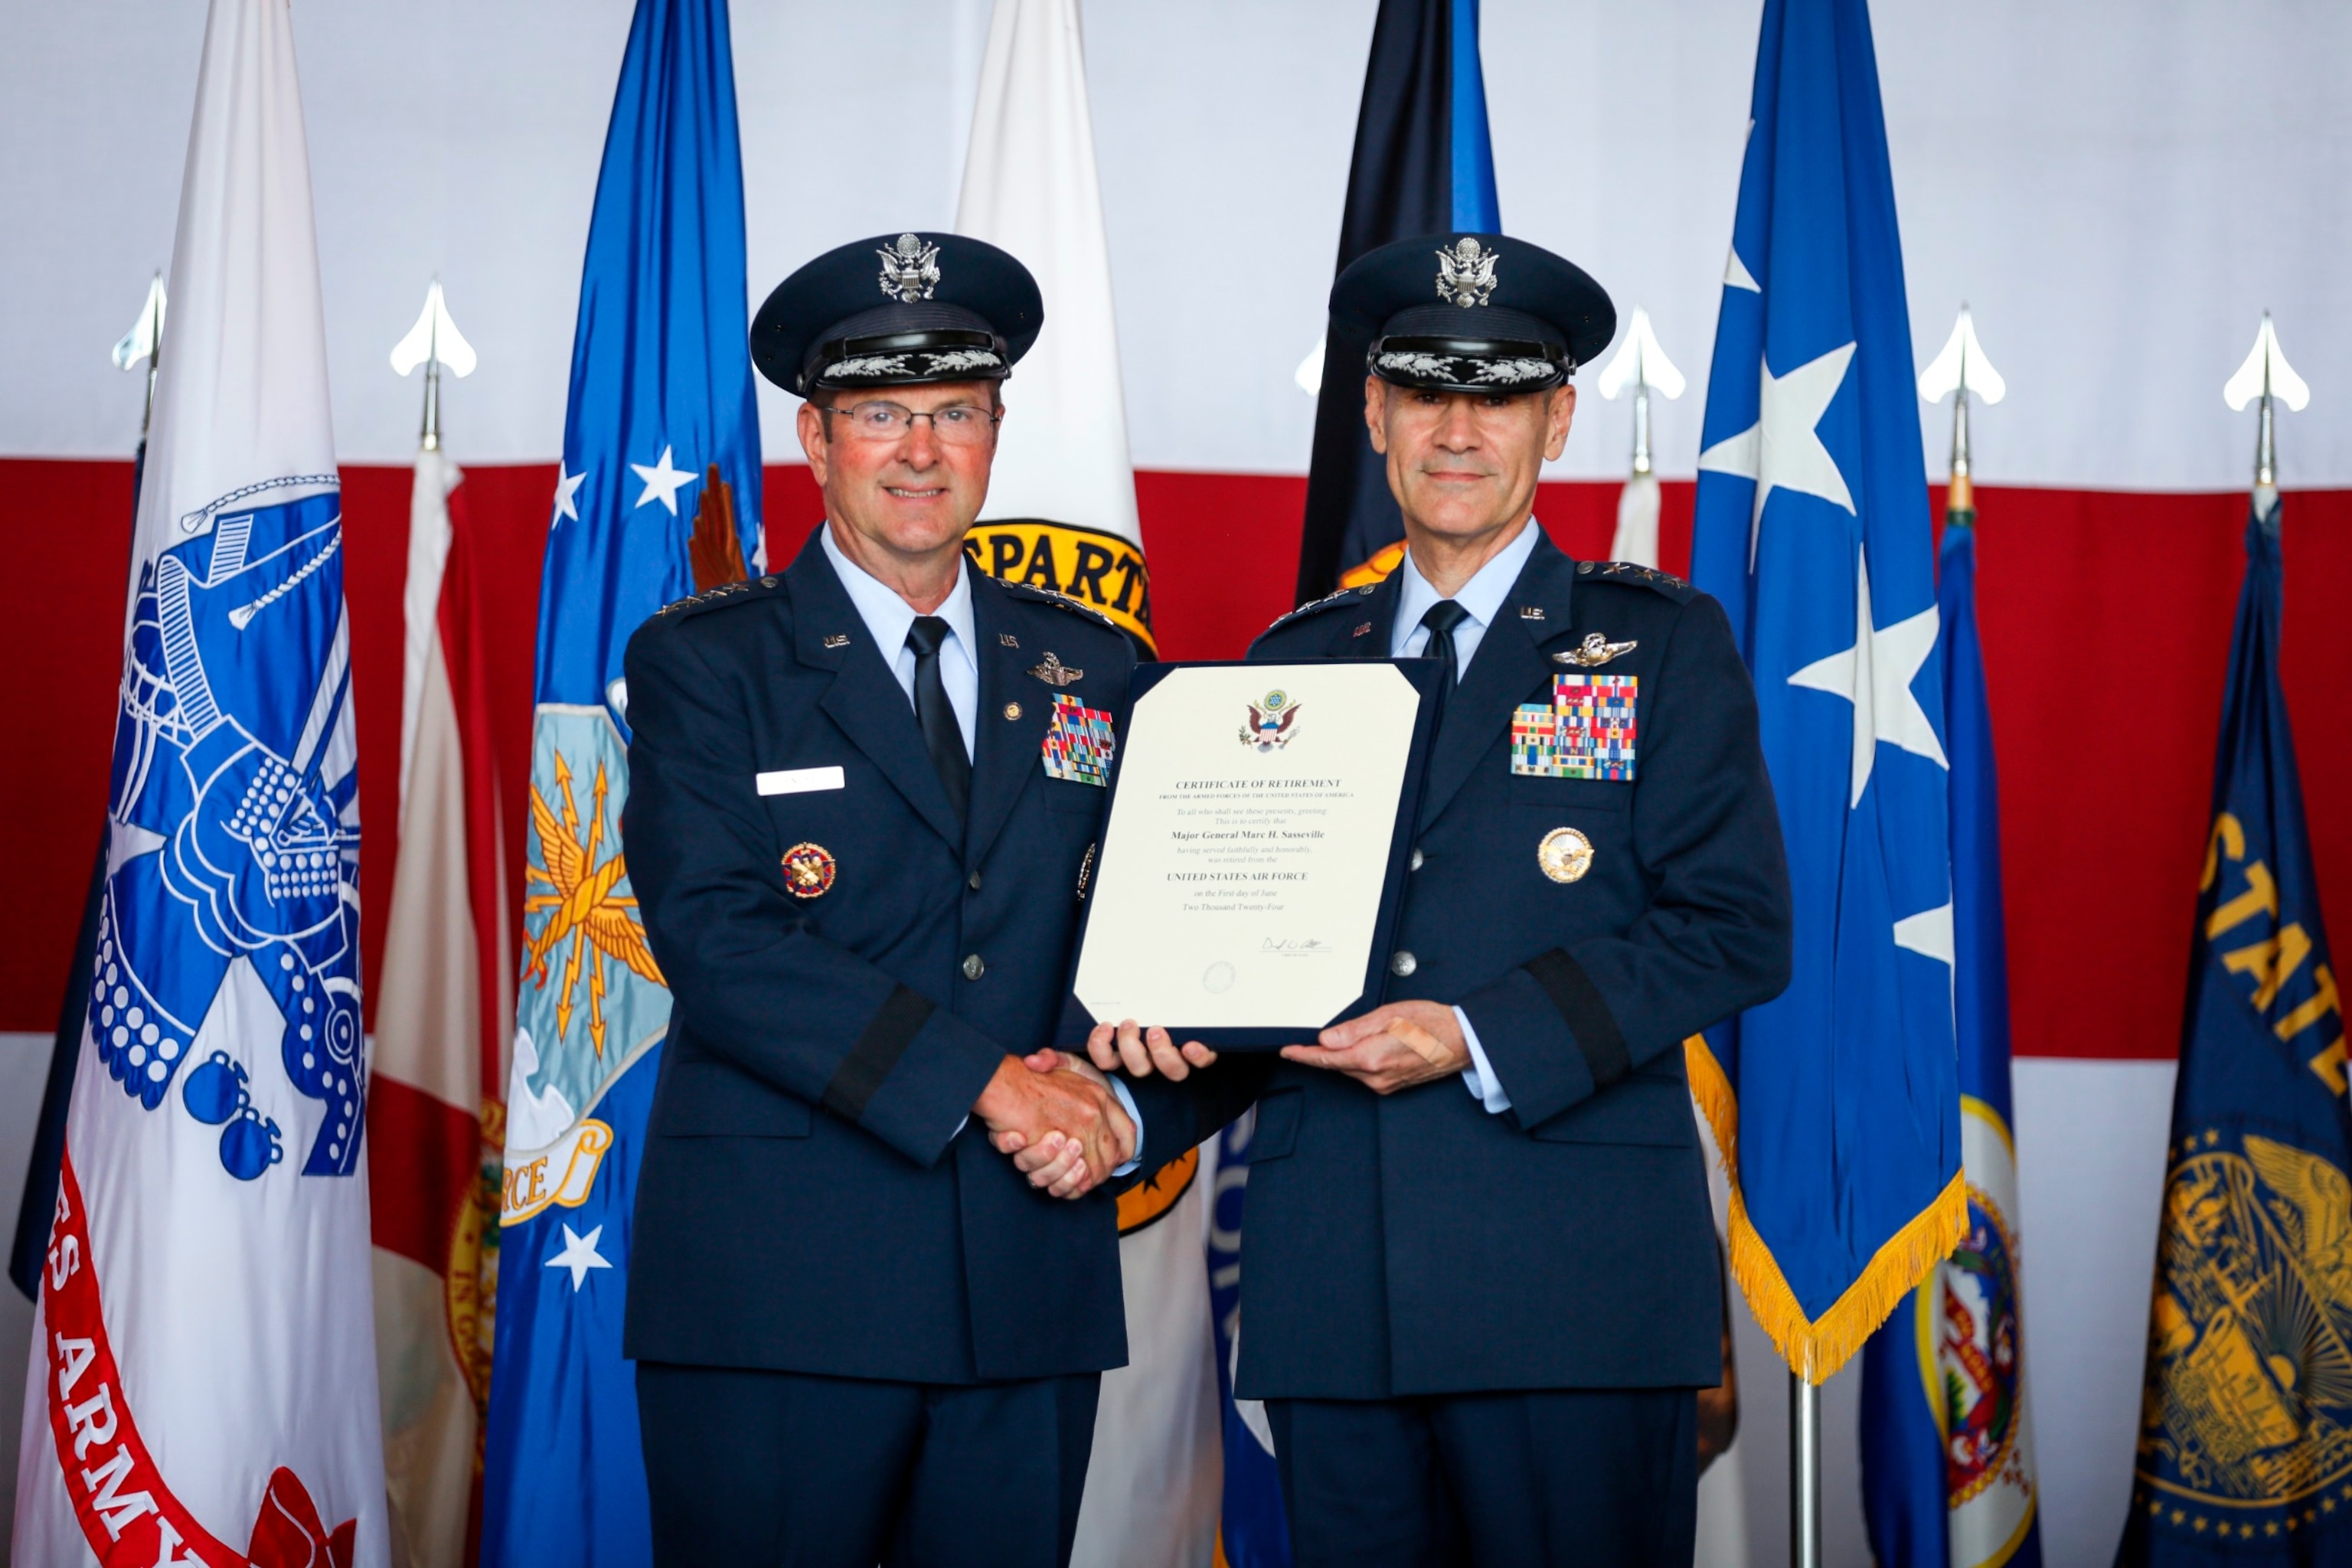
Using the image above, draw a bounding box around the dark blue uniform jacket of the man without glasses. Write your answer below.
[1214,524,1790,1399]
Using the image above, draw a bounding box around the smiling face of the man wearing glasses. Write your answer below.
[799,381,998,562]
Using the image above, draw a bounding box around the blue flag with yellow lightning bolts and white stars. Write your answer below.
[482,0,760,1568]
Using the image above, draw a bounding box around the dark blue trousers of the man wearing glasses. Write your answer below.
[638,1361,1101,1568]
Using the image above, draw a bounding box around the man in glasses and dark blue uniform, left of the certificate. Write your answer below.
[623,233,1138,1568]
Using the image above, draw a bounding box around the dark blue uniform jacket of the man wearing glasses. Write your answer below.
[621,536,1134,1382]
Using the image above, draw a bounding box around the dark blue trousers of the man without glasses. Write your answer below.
[1266,1390,1698,1568]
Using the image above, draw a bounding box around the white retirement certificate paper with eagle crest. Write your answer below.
[1075,661,1420,1030]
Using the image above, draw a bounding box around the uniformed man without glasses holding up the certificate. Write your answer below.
[1086,235,1790,1568]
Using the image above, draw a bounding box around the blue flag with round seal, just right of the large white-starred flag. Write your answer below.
[1863,495,2041,1568]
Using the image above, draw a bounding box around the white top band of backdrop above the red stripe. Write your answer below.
[0,0,2352,489]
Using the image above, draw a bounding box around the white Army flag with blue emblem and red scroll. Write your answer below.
[11,0,388,1568]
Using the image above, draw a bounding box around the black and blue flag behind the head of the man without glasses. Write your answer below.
[1298,0,1503,604]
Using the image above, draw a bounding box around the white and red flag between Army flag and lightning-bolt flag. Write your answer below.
[367,446,515,1568]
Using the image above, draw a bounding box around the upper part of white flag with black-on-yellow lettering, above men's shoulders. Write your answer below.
[955,0,1152,656]
